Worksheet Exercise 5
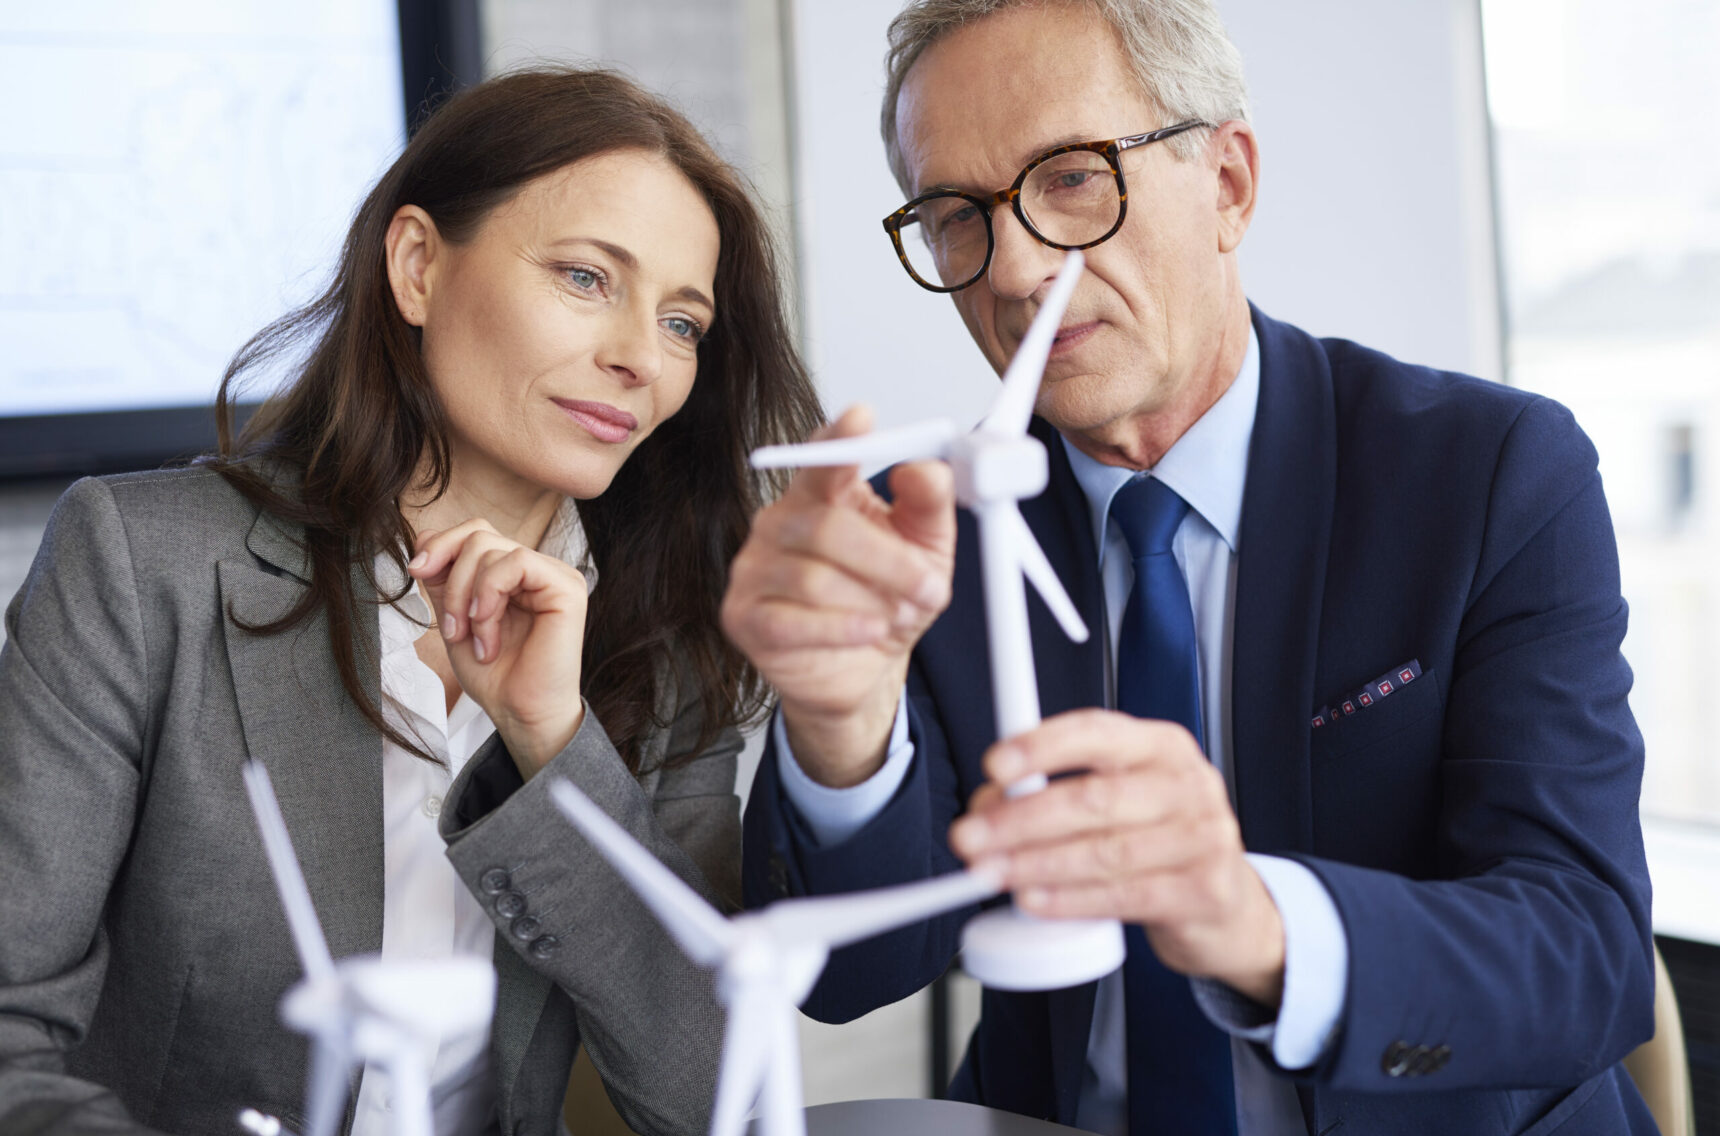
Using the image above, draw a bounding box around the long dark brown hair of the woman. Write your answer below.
[206,69,820,769]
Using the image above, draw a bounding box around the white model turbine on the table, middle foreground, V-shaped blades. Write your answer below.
[550,781,1001,1136]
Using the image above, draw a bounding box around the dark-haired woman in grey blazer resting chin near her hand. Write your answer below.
[0,71,817,1136]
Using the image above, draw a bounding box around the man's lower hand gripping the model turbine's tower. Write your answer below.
[949,709,1285,1007]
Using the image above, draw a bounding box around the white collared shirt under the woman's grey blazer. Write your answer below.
[353,499,597,1136]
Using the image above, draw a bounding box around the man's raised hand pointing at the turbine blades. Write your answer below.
[722,408,956,787]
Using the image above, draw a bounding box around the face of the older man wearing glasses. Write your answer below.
[896,3,1245,439]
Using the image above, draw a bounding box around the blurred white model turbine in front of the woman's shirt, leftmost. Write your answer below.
[239,761,495,1136]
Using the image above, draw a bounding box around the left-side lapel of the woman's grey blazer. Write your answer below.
[217,513,384,959]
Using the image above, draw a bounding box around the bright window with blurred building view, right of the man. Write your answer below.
[1481,0,1720,826]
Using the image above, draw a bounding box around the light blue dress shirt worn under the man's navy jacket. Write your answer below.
[774,329,1348,1136]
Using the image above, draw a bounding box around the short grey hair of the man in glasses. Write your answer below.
[881,0,1249,193]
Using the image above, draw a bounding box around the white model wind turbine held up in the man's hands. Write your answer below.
[752,250,1123,990]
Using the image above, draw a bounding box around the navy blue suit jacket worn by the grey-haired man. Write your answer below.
[745,312,1653,1136]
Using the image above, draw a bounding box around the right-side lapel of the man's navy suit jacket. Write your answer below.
[1232,310,1338,852]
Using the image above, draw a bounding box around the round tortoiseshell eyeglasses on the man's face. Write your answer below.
[884,122,1209,293]
